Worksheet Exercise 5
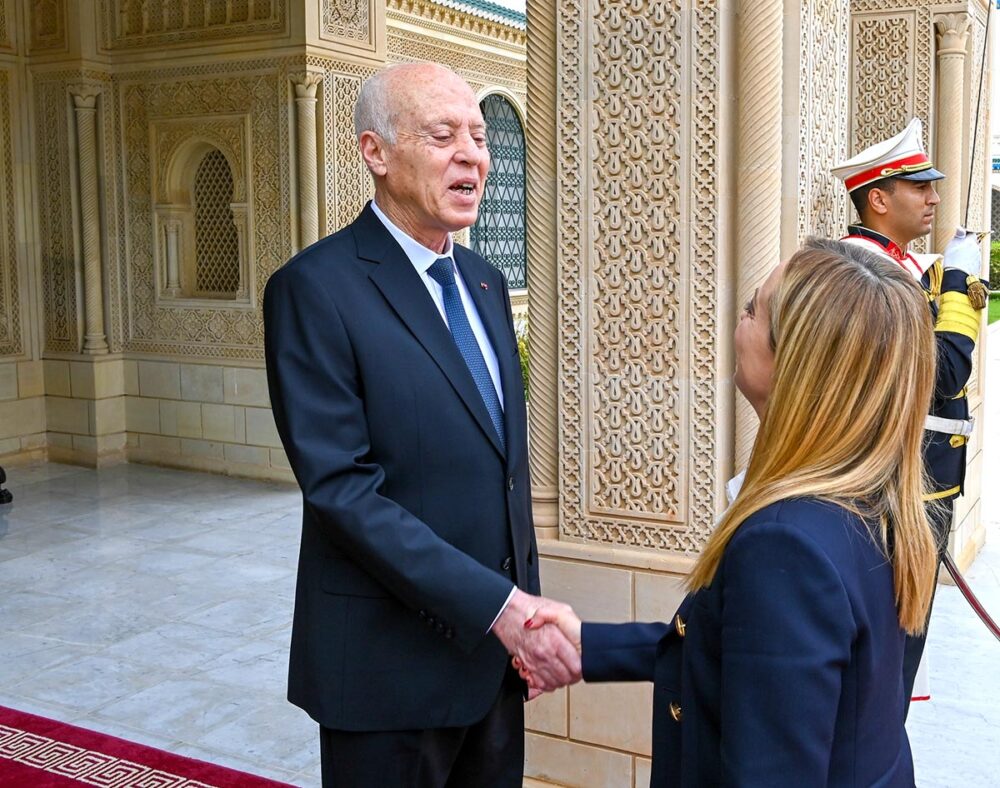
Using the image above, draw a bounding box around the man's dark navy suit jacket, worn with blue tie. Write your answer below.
[264,206,539,731]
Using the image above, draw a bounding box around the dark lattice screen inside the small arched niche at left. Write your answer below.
[194,148,240,295]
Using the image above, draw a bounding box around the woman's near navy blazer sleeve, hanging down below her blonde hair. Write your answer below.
[717,523,856,785]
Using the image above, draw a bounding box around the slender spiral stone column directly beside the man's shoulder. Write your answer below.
[526,0,559,538]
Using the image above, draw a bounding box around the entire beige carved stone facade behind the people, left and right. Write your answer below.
[0,0,989,786]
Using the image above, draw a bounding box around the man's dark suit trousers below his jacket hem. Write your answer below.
[319,668,524,788]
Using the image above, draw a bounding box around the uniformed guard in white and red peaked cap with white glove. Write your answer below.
[833,118,987,716]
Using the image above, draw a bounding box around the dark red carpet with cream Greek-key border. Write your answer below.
[0,706,287,788]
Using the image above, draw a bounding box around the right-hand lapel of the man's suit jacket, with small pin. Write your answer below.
[455,245,527,467]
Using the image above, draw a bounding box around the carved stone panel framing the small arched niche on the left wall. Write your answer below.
[116,60,290,359]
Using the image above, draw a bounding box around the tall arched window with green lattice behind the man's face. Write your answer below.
[470,94,527,289]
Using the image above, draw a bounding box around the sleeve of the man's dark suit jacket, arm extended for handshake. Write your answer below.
[264,264,513,652]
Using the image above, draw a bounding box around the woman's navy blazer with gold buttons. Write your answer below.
[583,498,914,788]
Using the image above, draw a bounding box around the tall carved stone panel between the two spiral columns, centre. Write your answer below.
[557,0,720,552]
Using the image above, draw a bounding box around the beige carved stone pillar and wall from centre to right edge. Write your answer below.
[527,0,989,786]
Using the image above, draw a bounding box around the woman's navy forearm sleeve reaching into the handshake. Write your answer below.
[580,622,670,682]
